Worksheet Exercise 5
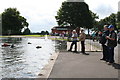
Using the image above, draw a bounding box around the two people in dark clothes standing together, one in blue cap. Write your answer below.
[100,25,117,64]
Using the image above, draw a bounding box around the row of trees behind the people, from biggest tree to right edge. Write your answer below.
[55,1,120,33]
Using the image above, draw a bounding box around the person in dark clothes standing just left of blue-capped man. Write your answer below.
[99,25,109,61]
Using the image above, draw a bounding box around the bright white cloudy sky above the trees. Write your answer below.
[0,0,119,32]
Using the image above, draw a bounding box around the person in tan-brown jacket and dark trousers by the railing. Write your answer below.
[79,29,88,55]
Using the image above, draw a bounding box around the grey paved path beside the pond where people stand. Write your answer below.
[49,40,120,80]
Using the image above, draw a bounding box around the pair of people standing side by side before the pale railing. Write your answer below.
[68,29,89,55]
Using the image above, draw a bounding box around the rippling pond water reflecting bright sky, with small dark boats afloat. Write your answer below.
[0,38,66,78]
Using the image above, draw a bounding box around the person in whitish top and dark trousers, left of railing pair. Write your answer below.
[68,30,78,52]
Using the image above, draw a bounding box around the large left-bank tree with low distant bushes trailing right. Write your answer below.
[1,8,49,35]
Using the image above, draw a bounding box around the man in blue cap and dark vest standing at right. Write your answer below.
[106,25,117,65]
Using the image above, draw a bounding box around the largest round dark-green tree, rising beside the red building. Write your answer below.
[55,1,93,32]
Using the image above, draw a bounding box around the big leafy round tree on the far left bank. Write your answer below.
[2,8,29,35]
